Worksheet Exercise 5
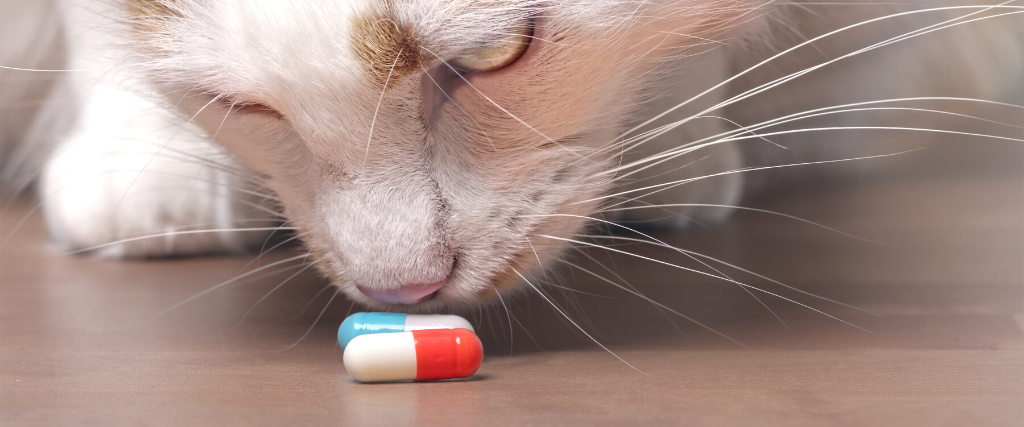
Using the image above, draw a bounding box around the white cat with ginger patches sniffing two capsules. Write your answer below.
[0,0,1024,311]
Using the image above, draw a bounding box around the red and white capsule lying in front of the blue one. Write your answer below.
[344,329,483,383]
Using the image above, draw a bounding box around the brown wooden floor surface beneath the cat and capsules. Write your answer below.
[0,144,1024,426]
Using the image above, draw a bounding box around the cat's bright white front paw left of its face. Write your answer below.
[39,82,273,258]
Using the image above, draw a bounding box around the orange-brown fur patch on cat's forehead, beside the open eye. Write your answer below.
[352,5,429,86]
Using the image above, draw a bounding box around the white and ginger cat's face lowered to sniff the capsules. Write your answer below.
[125,0,750,310]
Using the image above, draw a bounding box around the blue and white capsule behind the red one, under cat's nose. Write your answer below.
[338,312,476,350]
